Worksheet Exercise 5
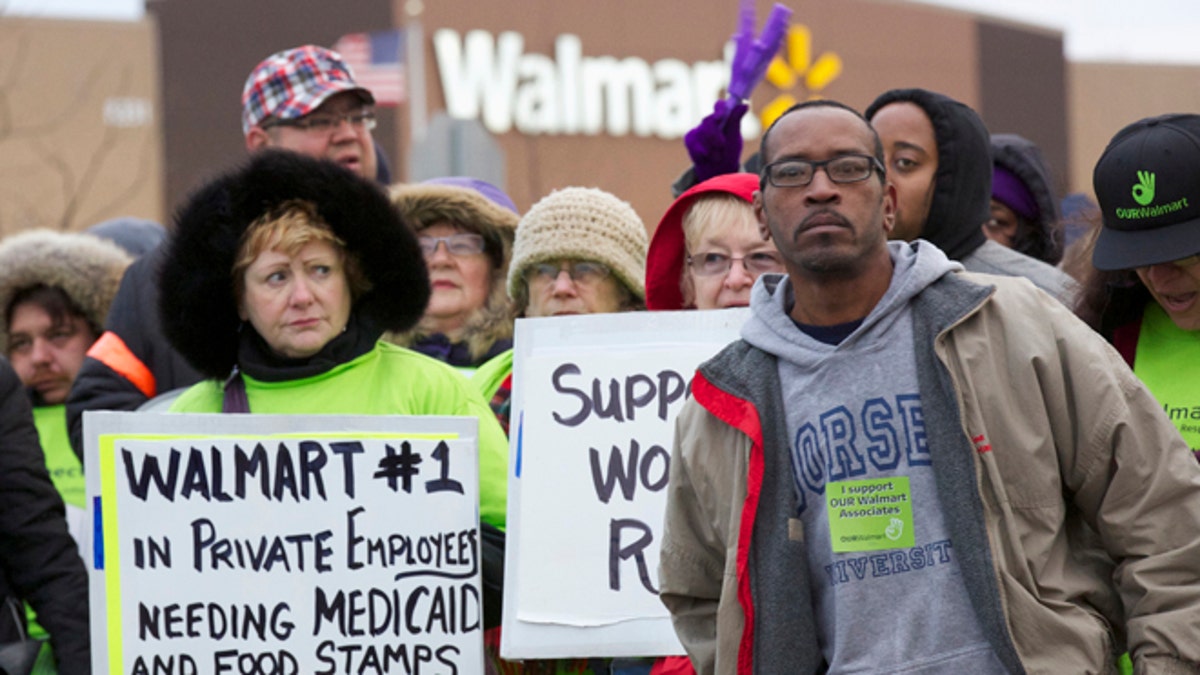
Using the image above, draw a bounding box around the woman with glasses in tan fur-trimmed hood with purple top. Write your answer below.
[389,177,520,369]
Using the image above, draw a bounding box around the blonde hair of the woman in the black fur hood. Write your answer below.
[232,199,371,300]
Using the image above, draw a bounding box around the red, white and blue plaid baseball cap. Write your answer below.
[241,44,374,133]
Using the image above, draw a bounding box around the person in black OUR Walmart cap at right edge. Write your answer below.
[1076,114,1200,459]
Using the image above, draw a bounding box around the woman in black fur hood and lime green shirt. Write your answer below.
[160,151,508,528]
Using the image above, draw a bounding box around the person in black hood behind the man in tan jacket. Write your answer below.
[865,89,1076,306]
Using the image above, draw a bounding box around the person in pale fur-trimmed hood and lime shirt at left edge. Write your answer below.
[0,224,131,659]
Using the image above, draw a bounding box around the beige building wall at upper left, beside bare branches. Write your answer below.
[0,18,163,235]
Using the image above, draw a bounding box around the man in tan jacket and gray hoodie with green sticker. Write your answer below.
[659,101,1200,675]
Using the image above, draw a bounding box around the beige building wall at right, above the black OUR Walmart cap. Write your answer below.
[1067,62,1200,195]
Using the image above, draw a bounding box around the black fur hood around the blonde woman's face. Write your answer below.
[158,150,430,378]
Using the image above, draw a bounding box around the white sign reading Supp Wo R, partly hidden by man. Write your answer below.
[500,310,748,658]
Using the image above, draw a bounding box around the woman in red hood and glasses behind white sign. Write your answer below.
[646,173,784,310]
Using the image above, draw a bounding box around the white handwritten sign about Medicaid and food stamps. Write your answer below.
[85,412,484,675]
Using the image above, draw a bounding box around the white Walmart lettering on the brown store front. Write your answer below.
[433,29,761,138]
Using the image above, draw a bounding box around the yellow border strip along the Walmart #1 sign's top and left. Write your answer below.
[93,431,460,673]
